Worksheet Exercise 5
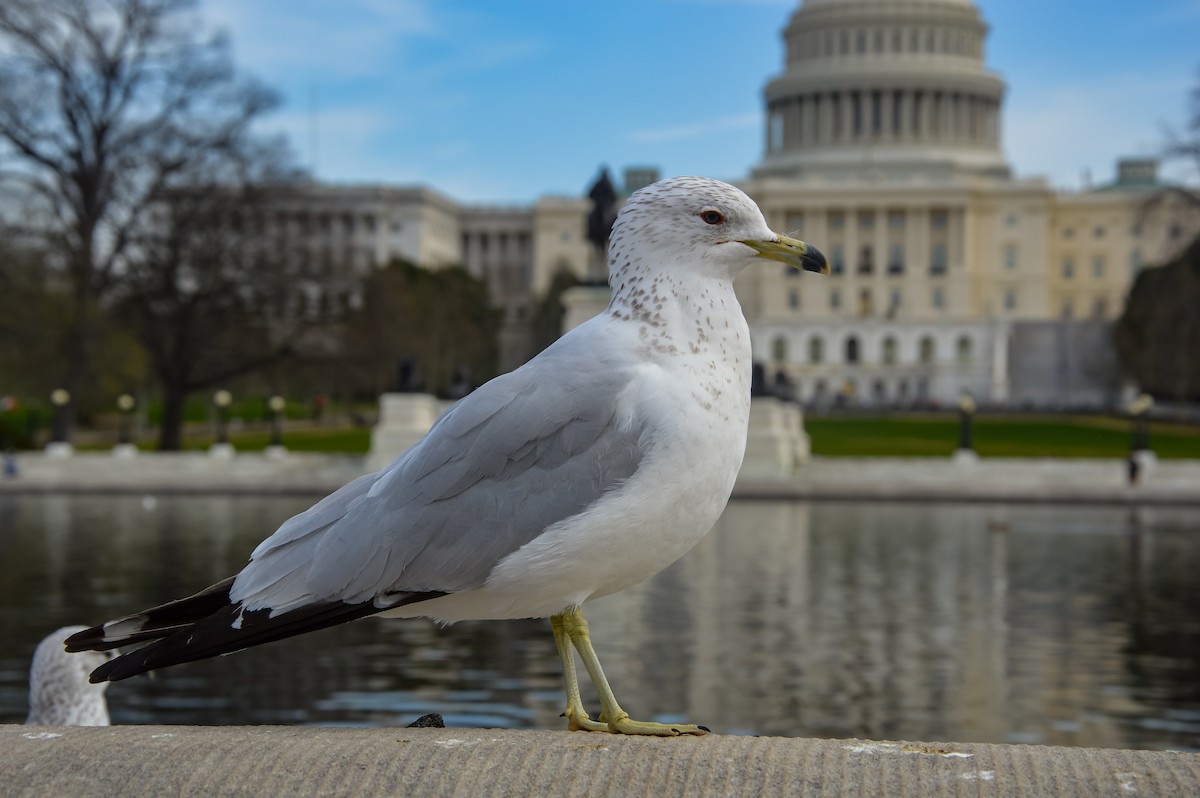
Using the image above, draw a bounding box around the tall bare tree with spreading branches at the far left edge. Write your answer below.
[0,0,276,422]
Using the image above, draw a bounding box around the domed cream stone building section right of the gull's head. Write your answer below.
[737,0,1196,404]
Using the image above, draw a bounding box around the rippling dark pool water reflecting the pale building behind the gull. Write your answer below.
[0,496,1200,749]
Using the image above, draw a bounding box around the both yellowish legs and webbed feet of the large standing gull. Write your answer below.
[551,607,708,737]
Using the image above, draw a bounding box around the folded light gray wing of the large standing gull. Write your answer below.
[230,350,643,611]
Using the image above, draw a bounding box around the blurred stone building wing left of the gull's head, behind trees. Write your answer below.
[266,184,592,370]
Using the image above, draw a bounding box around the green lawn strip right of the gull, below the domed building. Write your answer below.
[804,414,1200,460]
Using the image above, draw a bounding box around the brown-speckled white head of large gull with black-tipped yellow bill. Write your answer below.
[608,178,829,280]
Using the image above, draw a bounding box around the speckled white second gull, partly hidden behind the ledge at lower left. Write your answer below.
[25,626,112,726]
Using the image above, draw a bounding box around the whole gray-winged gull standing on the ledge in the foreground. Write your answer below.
[68,178,828,736]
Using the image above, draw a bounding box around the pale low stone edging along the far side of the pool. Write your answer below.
[0,452,1200,505]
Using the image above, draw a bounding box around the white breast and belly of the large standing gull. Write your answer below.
[385,286,750,622]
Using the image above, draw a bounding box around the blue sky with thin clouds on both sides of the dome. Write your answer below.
[200,0,1200,203]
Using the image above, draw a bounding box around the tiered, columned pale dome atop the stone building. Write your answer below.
[755,0,1009,178]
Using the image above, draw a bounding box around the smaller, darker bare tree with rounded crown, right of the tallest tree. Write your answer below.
[115,133,314,450]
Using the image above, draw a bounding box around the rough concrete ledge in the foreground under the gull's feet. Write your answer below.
[0,726,1200,798]
